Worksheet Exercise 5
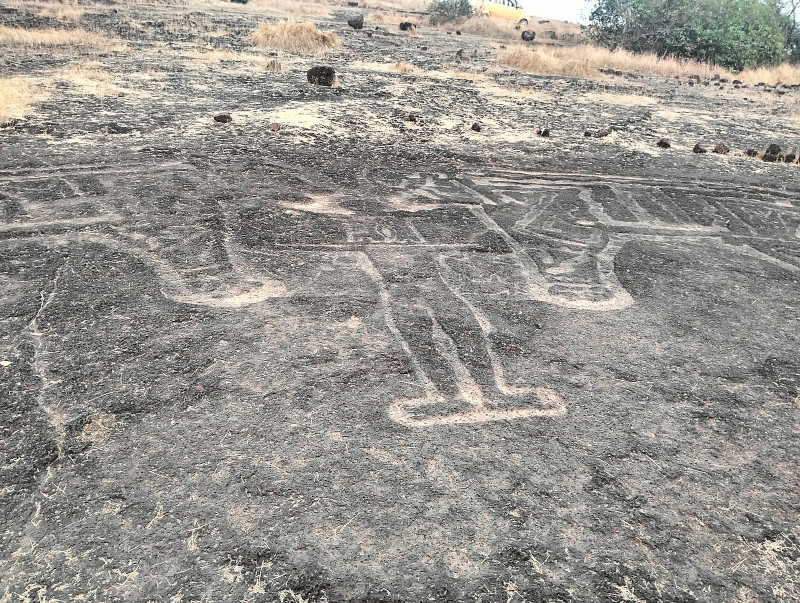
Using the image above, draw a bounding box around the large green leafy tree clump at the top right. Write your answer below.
[587,0,800,71]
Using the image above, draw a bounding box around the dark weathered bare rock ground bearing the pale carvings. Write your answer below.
[0,2,800,603]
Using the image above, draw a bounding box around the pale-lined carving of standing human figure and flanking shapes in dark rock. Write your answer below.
[0,166,800,427]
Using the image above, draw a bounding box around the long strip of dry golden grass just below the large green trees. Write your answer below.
[499,45,733,77]
